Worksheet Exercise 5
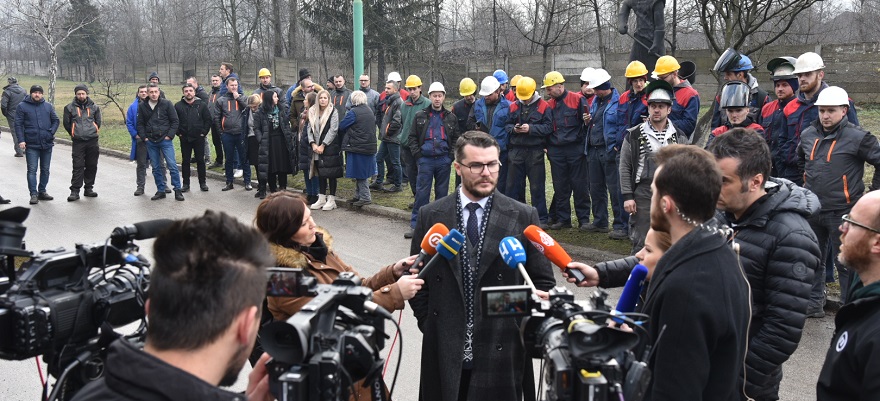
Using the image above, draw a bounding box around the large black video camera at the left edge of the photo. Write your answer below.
[0,207,171,400]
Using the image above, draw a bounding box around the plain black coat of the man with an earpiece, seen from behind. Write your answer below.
[642,223,749,401]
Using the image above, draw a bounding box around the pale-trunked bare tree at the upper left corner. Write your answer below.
[10,0,100,103]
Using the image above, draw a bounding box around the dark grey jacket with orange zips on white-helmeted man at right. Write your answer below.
[798,117,880,212]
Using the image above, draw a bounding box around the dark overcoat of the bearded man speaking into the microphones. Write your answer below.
[410,191,556,401]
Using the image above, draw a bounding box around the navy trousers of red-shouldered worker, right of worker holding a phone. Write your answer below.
[547,144,591,226]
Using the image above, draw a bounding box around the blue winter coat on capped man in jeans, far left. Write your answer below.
[15,97,59,149]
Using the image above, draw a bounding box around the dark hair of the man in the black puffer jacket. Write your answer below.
[709,127,772,185]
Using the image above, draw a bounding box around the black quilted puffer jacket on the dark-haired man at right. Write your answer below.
[718,178,824,399]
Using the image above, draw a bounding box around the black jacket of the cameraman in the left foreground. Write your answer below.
[73,339,247,401]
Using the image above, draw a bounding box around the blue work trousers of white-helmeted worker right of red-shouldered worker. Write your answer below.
[587,145,629,231]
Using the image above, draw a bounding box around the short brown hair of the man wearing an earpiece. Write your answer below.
[654,145,722,222]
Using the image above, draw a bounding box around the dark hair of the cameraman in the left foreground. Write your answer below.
[147,210,274,350]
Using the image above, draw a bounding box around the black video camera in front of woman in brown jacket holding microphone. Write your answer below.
[260,268,403,401]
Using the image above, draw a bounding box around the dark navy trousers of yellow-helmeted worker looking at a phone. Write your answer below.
[504,148,547,223]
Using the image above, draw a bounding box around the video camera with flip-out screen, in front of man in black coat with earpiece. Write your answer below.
[481,285,651,401]
